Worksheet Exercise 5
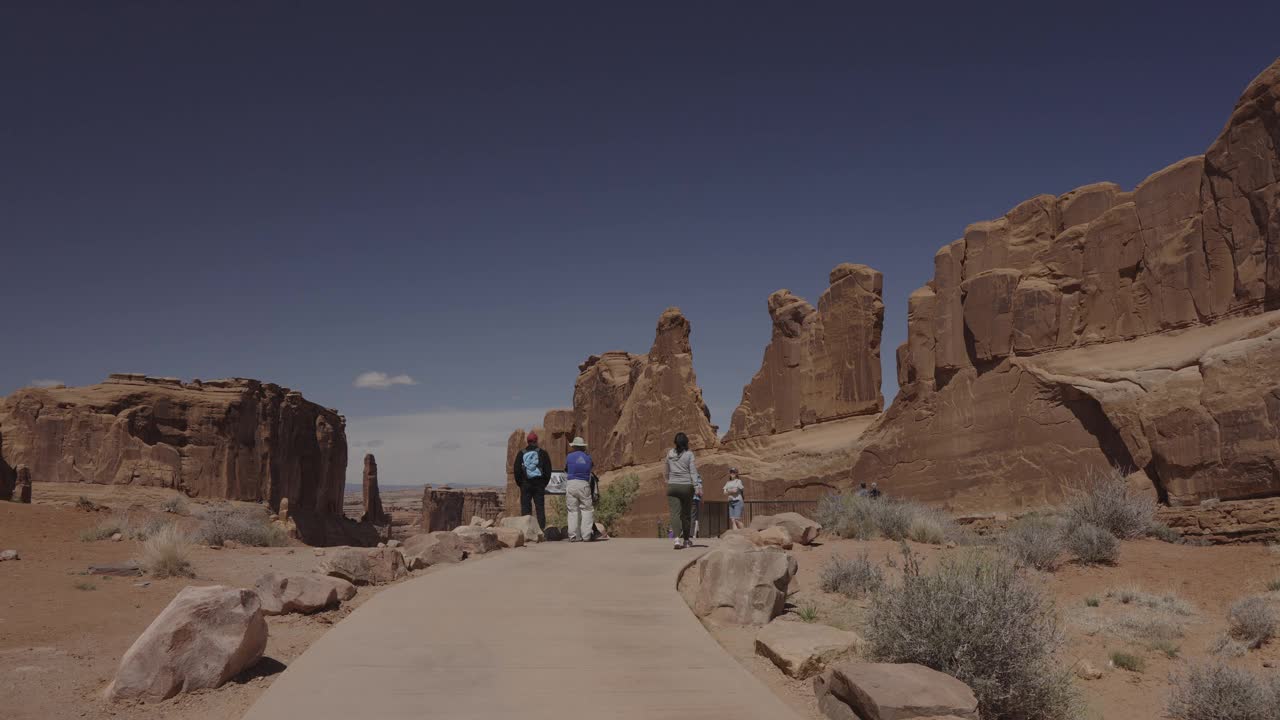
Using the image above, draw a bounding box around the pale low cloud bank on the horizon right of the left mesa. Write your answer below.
[347,409,544,486]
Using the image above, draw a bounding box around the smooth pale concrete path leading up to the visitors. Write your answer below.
[244,539,796,720]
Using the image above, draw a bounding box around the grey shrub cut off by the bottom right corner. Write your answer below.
[1167,662,1280,720]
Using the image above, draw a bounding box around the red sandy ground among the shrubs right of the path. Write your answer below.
[710,539,1280,720]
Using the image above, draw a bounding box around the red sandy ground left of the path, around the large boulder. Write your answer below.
[0,486,435,720]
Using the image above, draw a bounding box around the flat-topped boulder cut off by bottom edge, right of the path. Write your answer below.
[813,662,978,720]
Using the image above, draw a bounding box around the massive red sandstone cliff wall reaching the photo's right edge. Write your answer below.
[852,61,1280,506]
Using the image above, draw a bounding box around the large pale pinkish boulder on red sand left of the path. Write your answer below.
[106,585,266,701]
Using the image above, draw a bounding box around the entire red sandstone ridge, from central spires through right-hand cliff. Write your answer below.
[508,60,1280,533]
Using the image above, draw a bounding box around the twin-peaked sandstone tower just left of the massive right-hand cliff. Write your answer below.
[724,264,884,441]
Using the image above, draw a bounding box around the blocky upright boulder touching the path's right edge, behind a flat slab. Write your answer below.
[694,537,796,625]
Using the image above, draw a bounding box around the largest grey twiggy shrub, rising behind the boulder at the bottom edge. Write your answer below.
[867,545,1076,720]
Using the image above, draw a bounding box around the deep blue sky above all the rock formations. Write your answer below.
[0,1,1280,484]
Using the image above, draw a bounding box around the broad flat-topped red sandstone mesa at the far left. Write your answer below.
[0,374,347,516]
